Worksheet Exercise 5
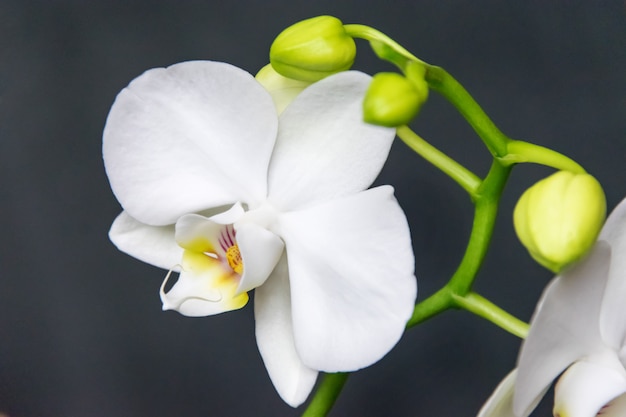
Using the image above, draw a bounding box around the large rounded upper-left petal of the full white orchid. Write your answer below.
[103,61,277,225]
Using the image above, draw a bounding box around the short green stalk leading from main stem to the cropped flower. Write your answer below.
[452,292,528,339]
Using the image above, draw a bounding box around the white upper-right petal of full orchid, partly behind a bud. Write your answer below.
[269,71,395,211]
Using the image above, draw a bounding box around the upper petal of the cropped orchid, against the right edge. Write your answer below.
[595,195,626,349]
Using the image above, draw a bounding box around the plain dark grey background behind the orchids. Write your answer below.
[0,0,626,417]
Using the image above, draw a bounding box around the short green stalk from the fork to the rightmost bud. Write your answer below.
[500,140,585,174]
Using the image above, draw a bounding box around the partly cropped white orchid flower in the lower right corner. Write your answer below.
[479,200,626,417]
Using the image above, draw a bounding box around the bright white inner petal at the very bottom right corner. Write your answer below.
[554,359,626,417]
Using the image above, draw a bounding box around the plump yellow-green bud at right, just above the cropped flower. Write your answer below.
[513,171,606,273]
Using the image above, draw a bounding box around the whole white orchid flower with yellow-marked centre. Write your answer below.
[103,61,416,406]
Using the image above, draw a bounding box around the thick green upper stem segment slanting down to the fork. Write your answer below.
[425,65,510,158]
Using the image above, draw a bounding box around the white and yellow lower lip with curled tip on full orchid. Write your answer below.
[160,250,248,317]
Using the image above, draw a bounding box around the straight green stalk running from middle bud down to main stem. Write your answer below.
[396,126,481,196]
